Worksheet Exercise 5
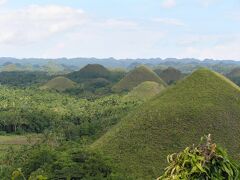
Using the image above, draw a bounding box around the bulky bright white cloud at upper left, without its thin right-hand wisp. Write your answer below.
[0,5,87,44]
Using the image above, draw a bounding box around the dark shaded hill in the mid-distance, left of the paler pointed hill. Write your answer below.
[67,64,111,83]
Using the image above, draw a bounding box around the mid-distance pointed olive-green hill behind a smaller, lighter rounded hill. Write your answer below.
[112,66,166,92]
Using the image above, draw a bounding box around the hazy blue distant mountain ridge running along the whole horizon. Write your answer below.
[0,57,240,74]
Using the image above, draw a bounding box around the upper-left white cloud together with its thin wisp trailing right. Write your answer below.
[0,5,138,46]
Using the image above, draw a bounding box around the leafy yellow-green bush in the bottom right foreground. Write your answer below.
[158,135,240,180]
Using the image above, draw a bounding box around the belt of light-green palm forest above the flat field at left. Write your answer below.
[0,86,139,139]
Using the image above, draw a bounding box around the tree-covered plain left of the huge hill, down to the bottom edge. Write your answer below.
[0,83,141,179]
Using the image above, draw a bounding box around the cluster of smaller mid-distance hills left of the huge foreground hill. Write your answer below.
[40,64,171,97]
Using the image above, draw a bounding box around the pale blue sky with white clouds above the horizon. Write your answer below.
[0,0,240,60]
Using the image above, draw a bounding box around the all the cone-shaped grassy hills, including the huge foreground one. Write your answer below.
[35,64,240,178]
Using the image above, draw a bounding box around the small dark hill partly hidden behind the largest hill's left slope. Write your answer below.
[154,67,183,84]
